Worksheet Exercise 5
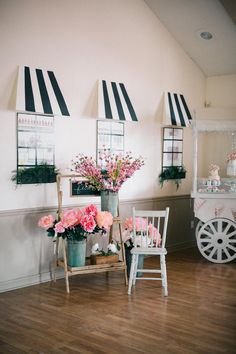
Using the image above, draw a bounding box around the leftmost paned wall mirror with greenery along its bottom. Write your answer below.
[17,113,55,184]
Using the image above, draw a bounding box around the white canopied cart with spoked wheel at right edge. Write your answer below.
[191,120,236,263]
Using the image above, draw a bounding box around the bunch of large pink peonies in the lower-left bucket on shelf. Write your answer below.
[38,204,113,240]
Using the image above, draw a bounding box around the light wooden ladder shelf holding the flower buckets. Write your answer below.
[54,174,128,294]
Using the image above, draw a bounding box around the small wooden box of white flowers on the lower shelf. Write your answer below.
[90,243,119,265]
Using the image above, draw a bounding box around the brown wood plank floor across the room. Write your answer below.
[0,249,236,354]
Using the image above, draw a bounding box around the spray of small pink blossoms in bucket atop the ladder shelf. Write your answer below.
[72,150,144,192]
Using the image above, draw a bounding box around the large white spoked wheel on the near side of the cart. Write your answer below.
[197,218,236,263]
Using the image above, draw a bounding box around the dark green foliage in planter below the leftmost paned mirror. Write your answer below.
[11,163,58,184]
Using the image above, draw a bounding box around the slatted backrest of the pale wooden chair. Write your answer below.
[132,207,169,249]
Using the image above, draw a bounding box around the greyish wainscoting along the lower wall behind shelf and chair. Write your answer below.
[0,195,196,292]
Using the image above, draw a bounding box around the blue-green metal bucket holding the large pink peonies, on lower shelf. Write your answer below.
[67,239,86,267]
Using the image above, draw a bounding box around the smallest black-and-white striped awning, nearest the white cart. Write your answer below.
[163,92,192,127]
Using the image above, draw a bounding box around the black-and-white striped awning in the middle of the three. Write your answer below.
[98,80,138,121]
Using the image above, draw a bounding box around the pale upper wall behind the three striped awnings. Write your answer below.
[0,0,205,210]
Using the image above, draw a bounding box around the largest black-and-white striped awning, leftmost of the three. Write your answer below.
[16,66,70,116]
